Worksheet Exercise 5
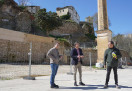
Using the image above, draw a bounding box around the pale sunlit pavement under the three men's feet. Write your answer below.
[0,67,132,91]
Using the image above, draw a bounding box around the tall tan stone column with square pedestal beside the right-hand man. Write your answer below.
[96,0,112,67]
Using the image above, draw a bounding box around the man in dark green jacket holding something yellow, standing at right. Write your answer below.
[104,41,122,89]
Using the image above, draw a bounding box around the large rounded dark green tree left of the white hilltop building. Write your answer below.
[35,9,62,35]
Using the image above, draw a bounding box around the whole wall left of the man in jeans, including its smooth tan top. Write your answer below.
[0,28,55,63]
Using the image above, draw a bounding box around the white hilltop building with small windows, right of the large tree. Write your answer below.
[56,6,80,24]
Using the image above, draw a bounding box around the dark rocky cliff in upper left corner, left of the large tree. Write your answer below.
[0,0,31,33]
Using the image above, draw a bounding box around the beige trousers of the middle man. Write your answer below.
[73,62,82,82]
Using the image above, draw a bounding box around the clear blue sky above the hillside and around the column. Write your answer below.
[15,0,132,35]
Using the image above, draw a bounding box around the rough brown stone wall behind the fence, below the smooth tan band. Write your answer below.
[0,39,67,64]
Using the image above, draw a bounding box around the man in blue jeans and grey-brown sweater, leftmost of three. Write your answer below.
[47,43,62,88]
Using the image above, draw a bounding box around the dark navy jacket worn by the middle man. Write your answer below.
[71,48,83,65]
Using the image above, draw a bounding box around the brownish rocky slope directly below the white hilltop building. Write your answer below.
[50,20,94,42]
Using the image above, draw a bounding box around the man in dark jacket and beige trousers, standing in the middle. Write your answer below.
[71,42,85,86]
